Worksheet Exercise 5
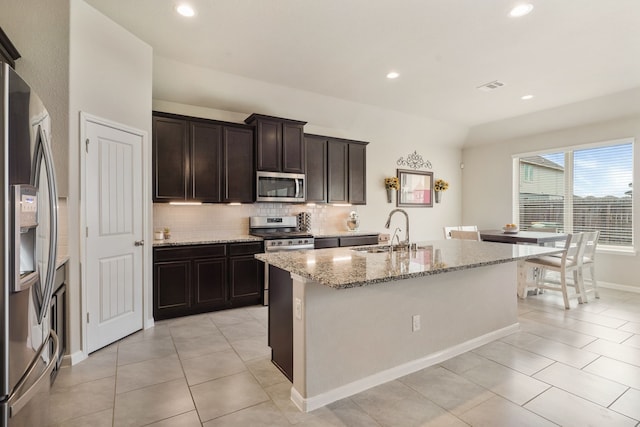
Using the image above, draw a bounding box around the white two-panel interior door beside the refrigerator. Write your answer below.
[84,121,144,352]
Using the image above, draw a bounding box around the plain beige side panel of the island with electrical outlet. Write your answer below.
[292,262,518,410]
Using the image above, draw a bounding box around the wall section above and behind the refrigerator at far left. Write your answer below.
[0,0,69,196]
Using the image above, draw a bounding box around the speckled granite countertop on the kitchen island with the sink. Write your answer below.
[256,239,562,289]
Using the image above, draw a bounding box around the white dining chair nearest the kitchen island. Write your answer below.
[518,233,586,309]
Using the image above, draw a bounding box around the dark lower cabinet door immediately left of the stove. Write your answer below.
[229,255,264,307]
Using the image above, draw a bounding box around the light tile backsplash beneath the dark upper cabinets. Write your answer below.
[153,203,357,235]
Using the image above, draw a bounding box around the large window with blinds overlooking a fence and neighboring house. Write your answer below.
[514,139,633,247]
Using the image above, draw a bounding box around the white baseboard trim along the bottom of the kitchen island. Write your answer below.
[291,323,520,412]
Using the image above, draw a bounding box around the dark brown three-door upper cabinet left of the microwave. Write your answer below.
[153,112,255,203]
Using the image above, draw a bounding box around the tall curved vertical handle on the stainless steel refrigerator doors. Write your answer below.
[31,126,58,323]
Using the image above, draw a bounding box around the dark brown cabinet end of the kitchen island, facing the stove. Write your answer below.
[269,265,293,382]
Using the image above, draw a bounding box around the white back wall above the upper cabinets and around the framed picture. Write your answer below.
[154,57,467,241]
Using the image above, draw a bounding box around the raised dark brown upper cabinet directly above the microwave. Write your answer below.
[245,114,306,173]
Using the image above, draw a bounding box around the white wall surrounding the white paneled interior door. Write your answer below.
[69,0,152,356]
